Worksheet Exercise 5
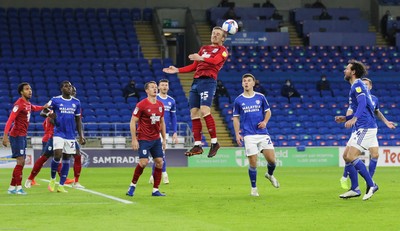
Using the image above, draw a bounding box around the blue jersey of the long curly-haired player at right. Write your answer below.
[349,79,377,130]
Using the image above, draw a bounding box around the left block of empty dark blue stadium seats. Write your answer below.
[0,8,188,139]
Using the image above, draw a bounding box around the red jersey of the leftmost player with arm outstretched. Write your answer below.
[6,98,43,137]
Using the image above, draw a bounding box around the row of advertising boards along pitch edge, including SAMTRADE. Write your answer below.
[0,146,400,168]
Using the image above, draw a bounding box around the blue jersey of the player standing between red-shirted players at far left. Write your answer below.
[49,95,81,139]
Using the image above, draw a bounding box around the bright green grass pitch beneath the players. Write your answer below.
[0,167,400,231]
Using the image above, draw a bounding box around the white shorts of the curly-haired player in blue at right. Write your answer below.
[347,128,379,152]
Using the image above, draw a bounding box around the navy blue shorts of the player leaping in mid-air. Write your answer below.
[189,77,217,109]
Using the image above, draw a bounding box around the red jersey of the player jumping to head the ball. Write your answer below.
[194,45,228,79]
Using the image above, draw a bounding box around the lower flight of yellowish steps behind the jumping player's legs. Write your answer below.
[179,73,235,147]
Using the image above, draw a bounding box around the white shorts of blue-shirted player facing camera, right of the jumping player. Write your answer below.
[244,135,274,156]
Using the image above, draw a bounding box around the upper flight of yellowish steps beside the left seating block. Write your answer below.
[135,22,161,60]
